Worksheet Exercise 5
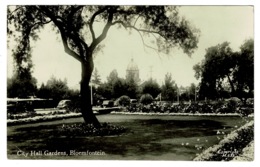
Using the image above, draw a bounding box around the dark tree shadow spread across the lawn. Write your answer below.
[7,119,230,157]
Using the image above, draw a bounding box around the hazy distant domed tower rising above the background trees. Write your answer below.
[126,58,140,83]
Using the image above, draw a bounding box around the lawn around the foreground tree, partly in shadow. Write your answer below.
[7,114,252,160]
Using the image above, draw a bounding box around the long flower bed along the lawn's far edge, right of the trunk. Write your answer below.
[123,101,254,116]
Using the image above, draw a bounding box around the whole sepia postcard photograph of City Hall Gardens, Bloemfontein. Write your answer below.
[5,4,255,162]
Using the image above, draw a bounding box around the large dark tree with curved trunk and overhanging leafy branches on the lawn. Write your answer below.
[7,5,198,126]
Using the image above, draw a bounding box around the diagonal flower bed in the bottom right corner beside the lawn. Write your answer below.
[194,120,254,161]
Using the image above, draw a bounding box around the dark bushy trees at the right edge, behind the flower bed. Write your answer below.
[193,39,254,102]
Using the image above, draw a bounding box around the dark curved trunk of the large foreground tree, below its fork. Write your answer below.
[80,60,100,127]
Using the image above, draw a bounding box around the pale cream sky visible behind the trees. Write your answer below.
[7,6,254,89]
